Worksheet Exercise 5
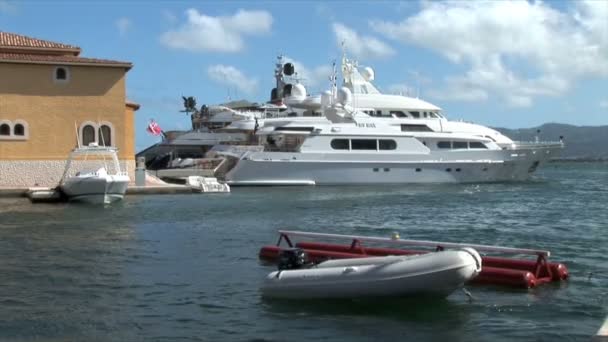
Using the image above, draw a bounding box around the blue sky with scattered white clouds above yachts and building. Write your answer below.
[0,0,608,150]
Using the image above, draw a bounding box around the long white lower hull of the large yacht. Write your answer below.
[226,147,560,186]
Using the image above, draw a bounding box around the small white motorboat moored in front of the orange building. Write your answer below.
[59,144,130,204]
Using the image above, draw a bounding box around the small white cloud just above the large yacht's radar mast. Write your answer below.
[332,23,395,59]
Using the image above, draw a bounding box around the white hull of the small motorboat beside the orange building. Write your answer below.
[60,175,129,204]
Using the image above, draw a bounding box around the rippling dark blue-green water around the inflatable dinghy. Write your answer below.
[0,163,608,341]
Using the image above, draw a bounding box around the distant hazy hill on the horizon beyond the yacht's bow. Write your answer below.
[495,123,608,160]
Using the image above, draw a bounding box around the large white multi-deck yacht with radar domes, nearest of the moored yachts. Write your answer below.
[216,61,563,185]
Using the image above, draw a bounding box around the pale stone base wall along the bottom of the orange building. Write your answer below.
[0,160,135,188]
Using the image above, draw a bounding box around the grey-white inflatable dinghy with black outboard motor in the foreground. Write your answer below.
[262,248,481,299]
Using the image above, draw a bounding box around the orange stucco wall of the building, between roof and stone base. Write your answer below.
[0,62,135,160]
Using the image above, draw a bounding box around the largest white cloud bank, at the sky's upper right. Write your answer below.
[370,0,608,107]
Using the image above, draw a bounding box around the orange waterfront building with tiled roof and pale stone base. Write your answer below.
[0,31,139,187]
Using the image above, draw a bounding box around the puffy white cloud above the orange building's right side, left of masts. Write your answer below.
[160,8,273,52]
